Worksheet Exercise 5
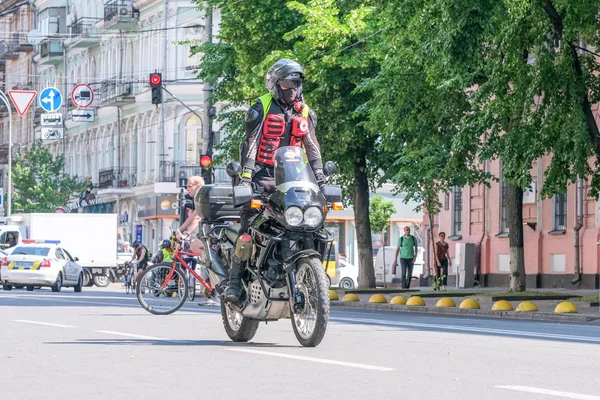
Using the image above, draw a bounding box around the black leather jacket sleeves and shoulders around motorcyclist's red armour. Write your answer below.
[240,100,323,171]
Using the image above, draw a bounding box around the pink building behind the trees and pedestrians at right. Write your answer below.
[423,158,600,288]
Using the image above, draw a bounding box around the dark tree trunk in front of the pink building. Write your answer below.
[506,184,526,292]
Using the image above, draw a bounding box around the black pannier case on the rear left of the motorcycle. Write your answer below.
[194,184,242,220]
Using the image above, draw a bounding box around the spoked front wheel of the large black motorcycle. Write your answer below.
[291,257,330,347]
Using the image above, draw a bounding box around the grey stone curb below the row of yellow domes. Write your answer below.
[331,301,600,322]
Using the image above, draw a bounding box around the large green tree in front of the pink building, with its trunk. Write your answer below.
[372,0,600,291]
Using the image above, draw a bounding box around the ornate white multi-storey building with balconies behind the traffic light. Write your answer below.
[33,0,219,249]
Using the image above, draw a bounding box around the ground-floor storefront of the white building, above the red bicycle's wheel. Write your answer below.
[137,195,179,253]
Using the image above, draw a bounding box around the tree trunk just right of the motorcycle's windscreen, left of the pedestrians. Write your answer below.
[354,158,376,288]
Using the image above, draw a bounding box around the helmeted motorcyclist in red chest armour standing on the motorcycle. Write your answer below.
[225,58,325,303]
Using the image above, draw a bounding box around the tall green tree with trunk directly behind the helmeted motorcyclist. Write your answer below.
[195,0,388,287]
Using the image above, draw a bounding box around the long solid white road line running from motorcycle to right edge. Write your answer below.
[329,317,600,343]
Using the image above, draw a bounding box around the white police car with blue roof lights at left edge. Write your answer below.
[0,239,83,292]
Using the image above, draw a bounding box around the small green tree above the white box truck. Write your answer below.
[12,140,85,213]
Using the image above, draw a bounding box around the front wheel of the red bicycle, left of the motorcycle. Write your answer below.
[136,263,188,315]
